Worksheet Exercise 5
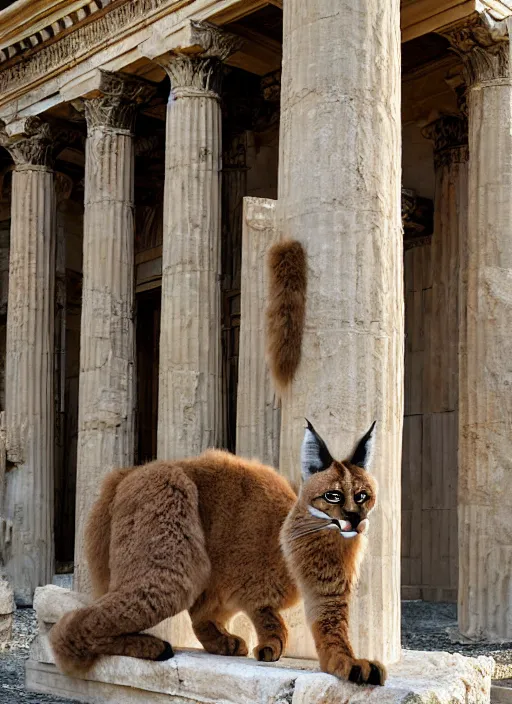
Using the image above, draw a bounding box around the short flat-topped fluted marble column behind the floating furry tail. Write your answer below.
[236,198,281,467]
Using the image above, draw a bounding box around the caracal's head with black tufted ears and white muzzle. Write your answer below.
[299,421,377,539]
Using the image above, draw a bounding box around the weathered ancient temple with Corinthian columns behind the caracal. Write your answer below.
[0,0,512,680]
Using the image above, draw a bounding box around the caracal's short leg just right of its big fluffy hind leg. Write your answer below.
[189,594,249,656]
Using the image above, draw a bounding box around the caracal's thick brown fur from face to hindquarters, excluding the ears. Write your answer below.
[50,432,385,684]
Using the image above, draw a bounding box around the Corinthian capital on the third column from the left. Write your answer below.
[156,21,243,98]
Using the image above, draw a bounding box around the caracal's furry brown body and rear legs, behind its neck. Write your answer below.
[50,450,298,676]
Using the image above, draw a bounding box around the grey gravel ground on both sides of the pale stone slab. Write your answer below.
[0,596,512,704]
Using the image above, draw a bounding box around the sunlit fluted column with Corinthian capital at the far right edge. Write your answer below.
[446,14,512,641]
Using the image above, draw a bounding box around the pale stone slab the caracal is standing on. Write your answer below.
[26,587,494,704]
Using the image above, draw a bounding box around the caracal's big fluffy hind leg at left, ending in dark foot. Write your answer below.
[50,466,210,674]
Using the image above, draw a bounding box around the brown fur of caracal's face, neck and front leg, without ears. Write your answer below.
[281,461,386,684]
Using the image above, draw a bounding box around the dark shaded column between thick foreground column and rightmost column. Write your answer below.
[420,115,468,601]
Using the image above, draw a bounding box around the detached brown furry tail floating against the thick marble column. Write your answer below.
[267,240,307,391]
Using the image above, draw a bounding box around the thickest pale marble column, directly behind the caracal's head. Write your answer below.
[278,0,404,663]
